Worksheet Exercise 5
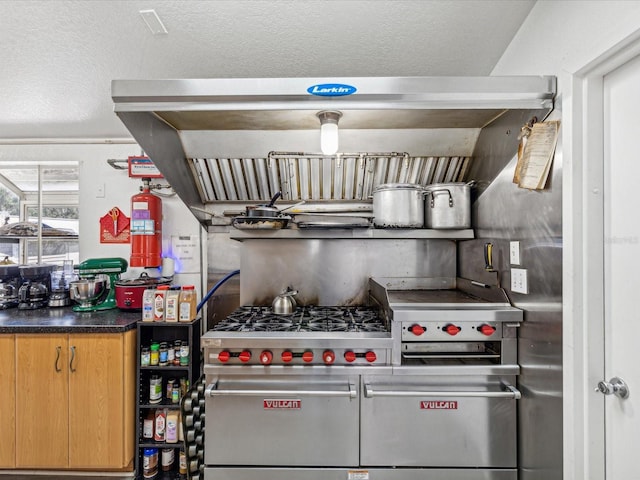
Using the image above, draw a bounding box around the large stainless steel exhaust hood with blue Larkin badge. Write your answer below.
[112,76,556,225]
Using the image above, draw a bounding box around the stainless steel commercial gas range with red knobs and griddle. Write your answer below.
[202,278,522,480]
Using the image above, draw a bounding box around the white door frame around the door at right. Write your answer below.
[559,29,640,480]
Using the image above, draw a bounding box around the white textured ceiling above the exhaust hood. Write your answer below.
[0,0,535,140]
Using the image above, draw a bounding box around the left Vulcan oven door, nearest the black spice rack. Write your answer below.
[205,375,360,467]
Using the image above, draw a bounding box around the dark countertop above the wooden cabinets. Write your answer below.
[0,307,142,334]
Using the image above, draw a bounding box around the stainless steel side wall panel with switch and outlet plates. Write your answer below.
[458,112,562,480]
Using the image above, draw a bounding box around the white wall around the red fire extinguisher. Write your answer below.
[0,143,206,298]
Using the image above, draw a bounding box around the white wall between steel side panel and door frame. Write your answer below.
[492,0,640,480]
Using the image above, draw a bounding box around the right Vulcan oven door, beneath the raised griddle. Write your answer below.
[361,375,520,468]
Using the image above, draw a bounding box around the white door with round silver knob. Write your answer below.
[600,51,640,480]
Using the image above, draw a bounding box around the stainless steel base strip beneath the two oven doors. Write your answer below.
[204,467,518,480]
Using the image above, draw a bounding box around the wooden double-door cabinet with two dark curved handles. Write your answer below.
[15,331,136,470]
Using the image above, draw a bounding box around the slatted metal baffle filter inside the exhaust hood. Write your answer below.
[188,152,471,204]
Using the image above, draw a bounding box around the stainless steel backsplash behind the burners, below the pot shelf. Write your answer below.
[240,239,456,305]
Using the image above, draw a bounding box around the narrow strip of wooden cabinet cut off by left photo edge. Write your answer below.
[0,335,16,469]
